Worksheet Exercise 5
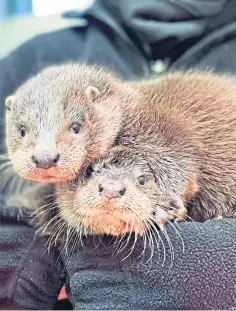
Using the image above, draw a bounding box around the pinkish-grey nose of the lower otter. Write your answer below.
[98,181,126,199]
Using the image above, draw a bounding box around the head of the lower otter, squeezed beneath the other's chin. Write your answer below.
[57,147,186,236]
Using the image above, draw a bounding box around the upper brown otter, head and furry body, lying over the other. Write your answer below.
[6,65,236,227]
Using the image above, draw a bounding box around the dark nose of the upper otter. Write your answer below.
[32,151,60,169]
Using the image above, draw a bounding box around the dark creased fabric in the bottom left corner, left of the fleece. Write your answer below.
[0,196,63,310]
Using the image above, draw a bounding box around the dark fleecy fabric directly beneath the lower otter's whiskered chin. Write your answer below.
[64,220,236,310]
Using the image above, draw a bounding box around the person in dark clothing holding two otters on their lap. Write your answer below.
[0,0,236,310]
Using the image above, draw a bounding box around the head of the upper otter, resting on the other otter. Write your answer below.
[6,64,133,183]
